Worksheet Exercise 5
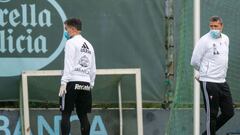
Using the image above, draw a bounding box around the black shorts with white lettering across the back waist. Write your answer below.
[60,82,92,113]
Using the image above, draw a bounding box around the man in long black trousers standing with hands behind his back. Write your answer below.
[191,16,234,135]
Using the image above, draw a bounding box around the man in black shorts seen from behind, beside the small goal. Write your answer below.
[59,18,96,135]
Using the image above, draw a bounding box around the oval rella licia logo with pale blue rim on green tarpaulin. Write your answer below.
[0,0,67,77]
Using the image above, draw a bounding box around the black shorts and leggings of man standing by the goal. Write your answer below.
[60,82,92,135]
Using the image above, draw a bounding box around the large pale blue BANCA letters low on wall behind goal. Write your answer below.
[0,115,108,135]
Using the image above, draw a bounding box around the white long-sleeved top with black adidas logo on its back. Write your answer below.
[61,35,96,87]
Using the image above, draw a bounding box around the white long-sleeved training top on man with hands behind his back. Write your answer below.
[191,33,229,83]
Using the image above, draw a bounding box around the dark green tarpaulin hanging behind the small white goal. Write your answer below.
[0,0,165,102]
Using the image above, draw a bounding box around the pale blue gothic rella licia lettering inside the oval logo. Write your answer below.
[0,4,52,54]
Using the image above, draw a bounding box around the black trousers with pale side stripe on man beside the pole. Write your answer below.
[200,81,234,135]
